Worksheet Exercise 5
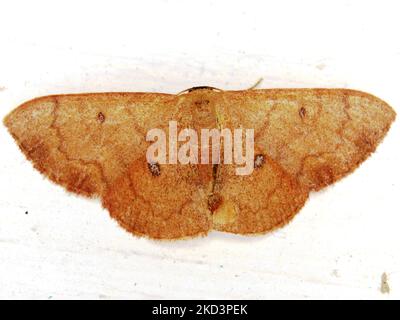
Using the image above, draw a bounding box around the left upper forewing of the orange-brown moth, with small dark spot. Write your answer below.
[4,93,171,196]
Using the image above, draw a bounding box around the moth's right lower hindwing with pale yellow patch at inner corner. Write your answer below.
[212,157,308,234]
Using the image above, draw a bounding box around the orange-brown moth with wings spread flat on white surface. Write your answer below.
[4,87,396,239]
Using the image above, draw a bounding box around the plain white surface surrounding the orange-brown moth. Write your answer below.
[0,0,400,299]
